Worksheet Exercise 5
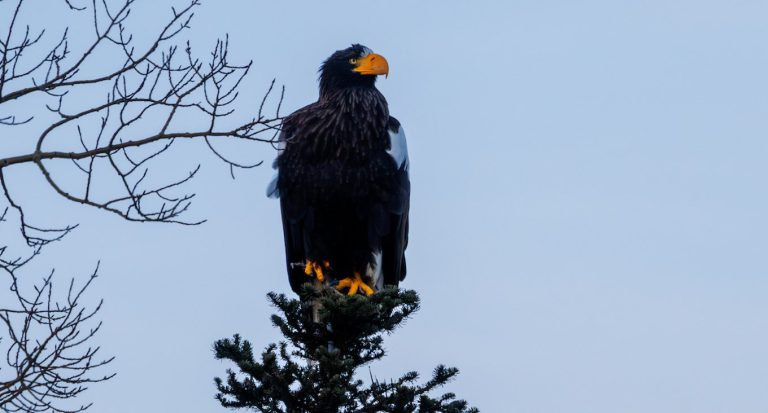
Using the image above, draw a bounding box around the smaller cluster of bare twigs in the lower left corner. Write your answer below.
[0,266,114,413]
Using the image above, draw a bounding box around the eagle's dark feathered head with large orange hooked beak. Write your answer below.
[320,44,389,91]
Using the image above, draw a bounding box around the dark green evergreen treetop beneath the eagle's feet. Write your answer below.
[214,286,478,413]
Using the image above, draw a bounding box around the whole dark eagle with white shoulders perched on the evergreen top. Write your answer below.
[267,44,411,295]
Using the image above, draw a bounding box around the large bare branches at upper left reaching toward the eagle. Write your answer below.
[0,0,283,225]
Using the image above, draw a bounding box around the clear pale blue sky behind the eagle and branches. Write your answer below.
[3,0,768,413]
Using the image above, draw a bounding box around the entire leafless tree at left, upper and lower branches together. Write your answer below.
[0,0,284,413]
